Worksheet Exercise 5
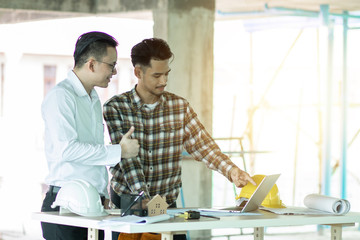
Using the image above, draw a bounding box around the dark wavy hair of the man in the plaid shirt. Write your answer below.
[131,38,174,67]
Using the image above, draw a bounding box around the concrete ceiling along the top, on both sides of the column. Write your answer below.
[0,0,360,24]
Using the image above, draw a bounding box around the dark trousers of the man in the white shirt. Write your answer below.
[41,188,104,240]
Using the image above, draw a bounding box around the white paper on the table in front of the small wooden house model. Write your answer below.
[99,214,171,226]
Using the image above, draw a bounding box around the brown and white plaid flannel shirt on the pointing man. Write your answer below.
[104,88,235,204]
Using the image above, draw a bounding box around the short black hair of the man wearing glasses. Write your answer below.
[74,32,118,67]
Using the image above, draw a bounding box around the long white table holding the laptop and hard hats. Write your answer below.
[32,211,360,240]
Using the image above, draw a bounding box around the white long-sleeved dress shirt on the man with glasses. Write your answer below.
[41,71,121,198]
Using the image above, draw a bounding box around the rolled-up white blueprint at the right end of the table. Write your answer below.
[304,194,350,215]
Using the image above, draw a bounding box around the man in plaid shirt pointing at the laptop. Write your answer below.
[104,38,256,210]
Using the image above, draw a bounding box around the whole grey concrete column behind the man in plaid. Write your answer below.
[153,0,215,239]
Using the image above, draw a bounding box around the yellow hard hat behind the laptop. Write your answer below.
[235,175,286,208]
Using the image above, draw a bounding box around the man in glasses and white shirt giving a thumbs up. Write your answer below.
[41,32,139,240]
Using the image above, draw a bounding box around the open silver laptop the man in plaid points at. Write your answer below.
[201,174,280,213]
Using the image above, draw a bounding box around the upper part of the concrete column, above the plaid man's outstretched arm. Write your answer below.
[153,0,215,133]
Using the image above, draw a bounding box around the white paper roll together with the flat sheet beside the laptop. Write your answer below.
[261,194,350,215]
